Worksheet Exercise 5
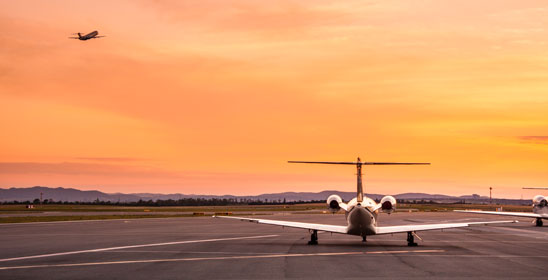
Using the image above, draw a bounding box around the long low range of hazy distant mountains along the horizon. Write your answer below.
[0,187,500,202]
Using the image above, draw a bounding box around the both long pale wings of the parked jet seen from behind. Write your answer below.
[213,216,517,234]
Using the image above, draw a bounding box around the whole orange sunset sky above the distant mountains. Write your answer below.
[0,0,548,198]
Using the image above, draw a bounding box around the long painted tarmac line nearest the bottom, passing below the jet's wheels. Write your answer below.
[0,250,445,270]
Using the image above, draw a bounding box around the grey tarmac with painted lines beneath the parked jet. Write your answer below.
[0,212,548,279]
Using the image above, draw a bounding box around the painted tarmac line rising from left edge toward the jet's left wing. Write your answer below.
[0,234,279,262]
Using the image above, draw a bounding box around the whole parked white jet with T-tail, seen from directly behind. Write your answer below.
[213,158,517,246]
